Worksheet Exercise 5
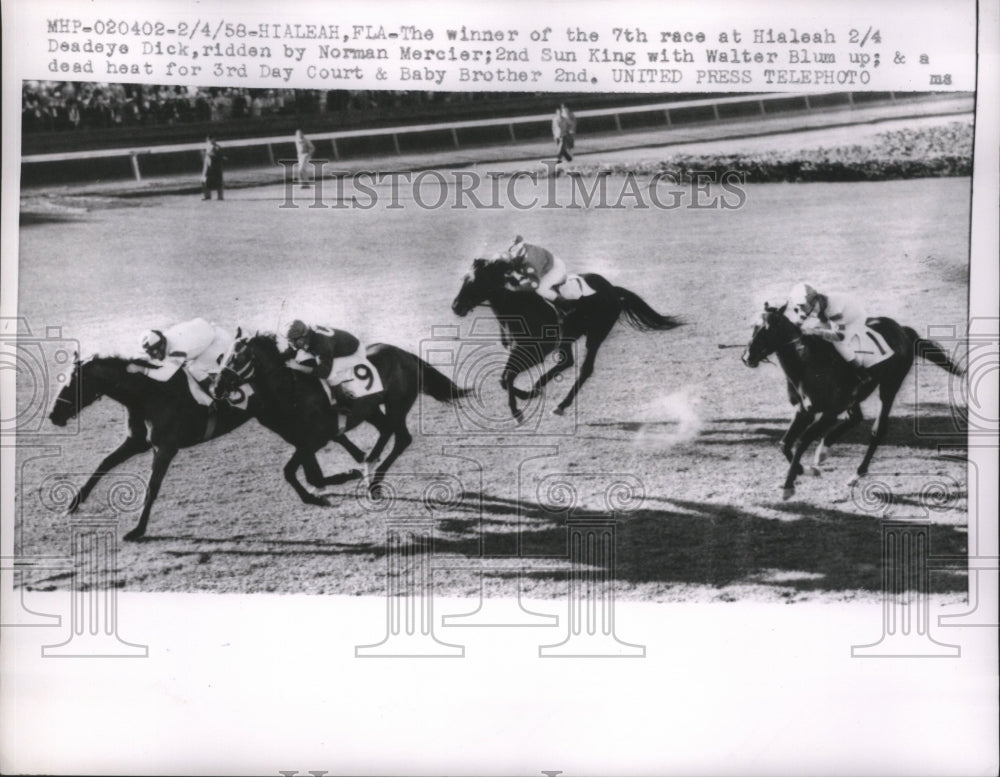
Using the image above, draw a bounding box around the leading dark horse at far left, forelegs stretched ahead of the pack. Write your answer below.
[49,356,250,540]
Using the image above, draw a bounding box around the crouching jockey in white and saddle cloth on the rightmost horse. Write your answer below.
[785,283,892,380]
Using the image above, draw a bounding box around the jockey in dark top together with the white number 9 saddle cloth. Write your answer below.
[285,319,382,406]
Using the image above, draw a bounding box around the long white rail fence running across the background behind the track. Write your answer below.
[21,92,971,181]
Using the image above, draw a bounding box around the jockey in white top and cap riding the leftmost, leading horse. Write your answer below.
[128,318,233,405]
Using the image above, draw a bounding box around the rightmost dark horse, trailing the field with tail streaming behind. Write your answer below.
[743,304,964,499]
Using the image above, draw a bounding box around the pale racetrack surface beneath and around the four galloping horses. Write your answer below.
[17,169,970,601]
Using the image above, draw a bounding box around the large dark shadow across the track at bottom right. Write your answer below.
[424,496,968,598]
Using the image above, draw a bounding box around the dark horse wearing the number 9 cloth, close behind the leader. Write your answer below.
[213,334,468,498]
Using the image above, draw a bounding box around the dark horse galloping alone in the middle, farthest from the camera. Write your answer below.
[451,259,681,421]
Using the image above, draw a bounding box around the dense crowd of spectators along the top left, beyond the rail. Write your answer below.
[21,81,528,132]
